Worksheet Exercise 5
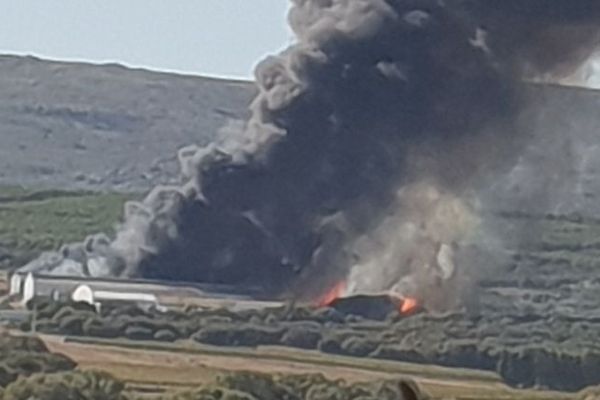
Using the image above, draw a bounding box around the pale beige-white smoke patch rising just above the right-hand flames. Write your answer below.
[348,182,479,306]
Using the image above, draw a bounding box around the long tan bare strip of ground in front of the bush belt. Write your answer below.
[43,336,573,399]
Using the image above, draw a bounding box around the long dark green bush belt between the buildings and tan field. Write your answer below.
[23,302,600,390]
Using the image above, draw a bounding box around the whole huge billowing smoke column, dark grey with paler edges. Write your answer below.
[24,0,600,307]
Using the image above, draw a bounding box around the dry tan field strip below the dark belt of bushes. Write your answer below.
[38,336,581,400]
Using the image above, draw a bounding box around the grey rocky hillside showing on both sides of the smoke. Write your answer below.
[0,56,600,215]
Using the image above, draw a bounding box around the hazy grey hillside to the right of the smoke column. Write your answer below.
[488,85,600,216]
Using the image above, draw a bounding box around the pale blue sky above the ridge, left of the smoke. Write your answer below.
[0,0,291,78]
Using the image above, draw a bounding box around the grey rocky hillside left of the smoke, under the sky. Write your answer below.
[0,56,254,190]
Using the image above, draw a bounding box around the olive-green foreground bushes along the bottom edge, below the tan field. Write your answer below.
[0,332,434,400]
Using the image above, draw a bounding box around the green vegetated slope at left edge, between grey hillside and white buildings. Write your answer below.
[0,187,136,268]
